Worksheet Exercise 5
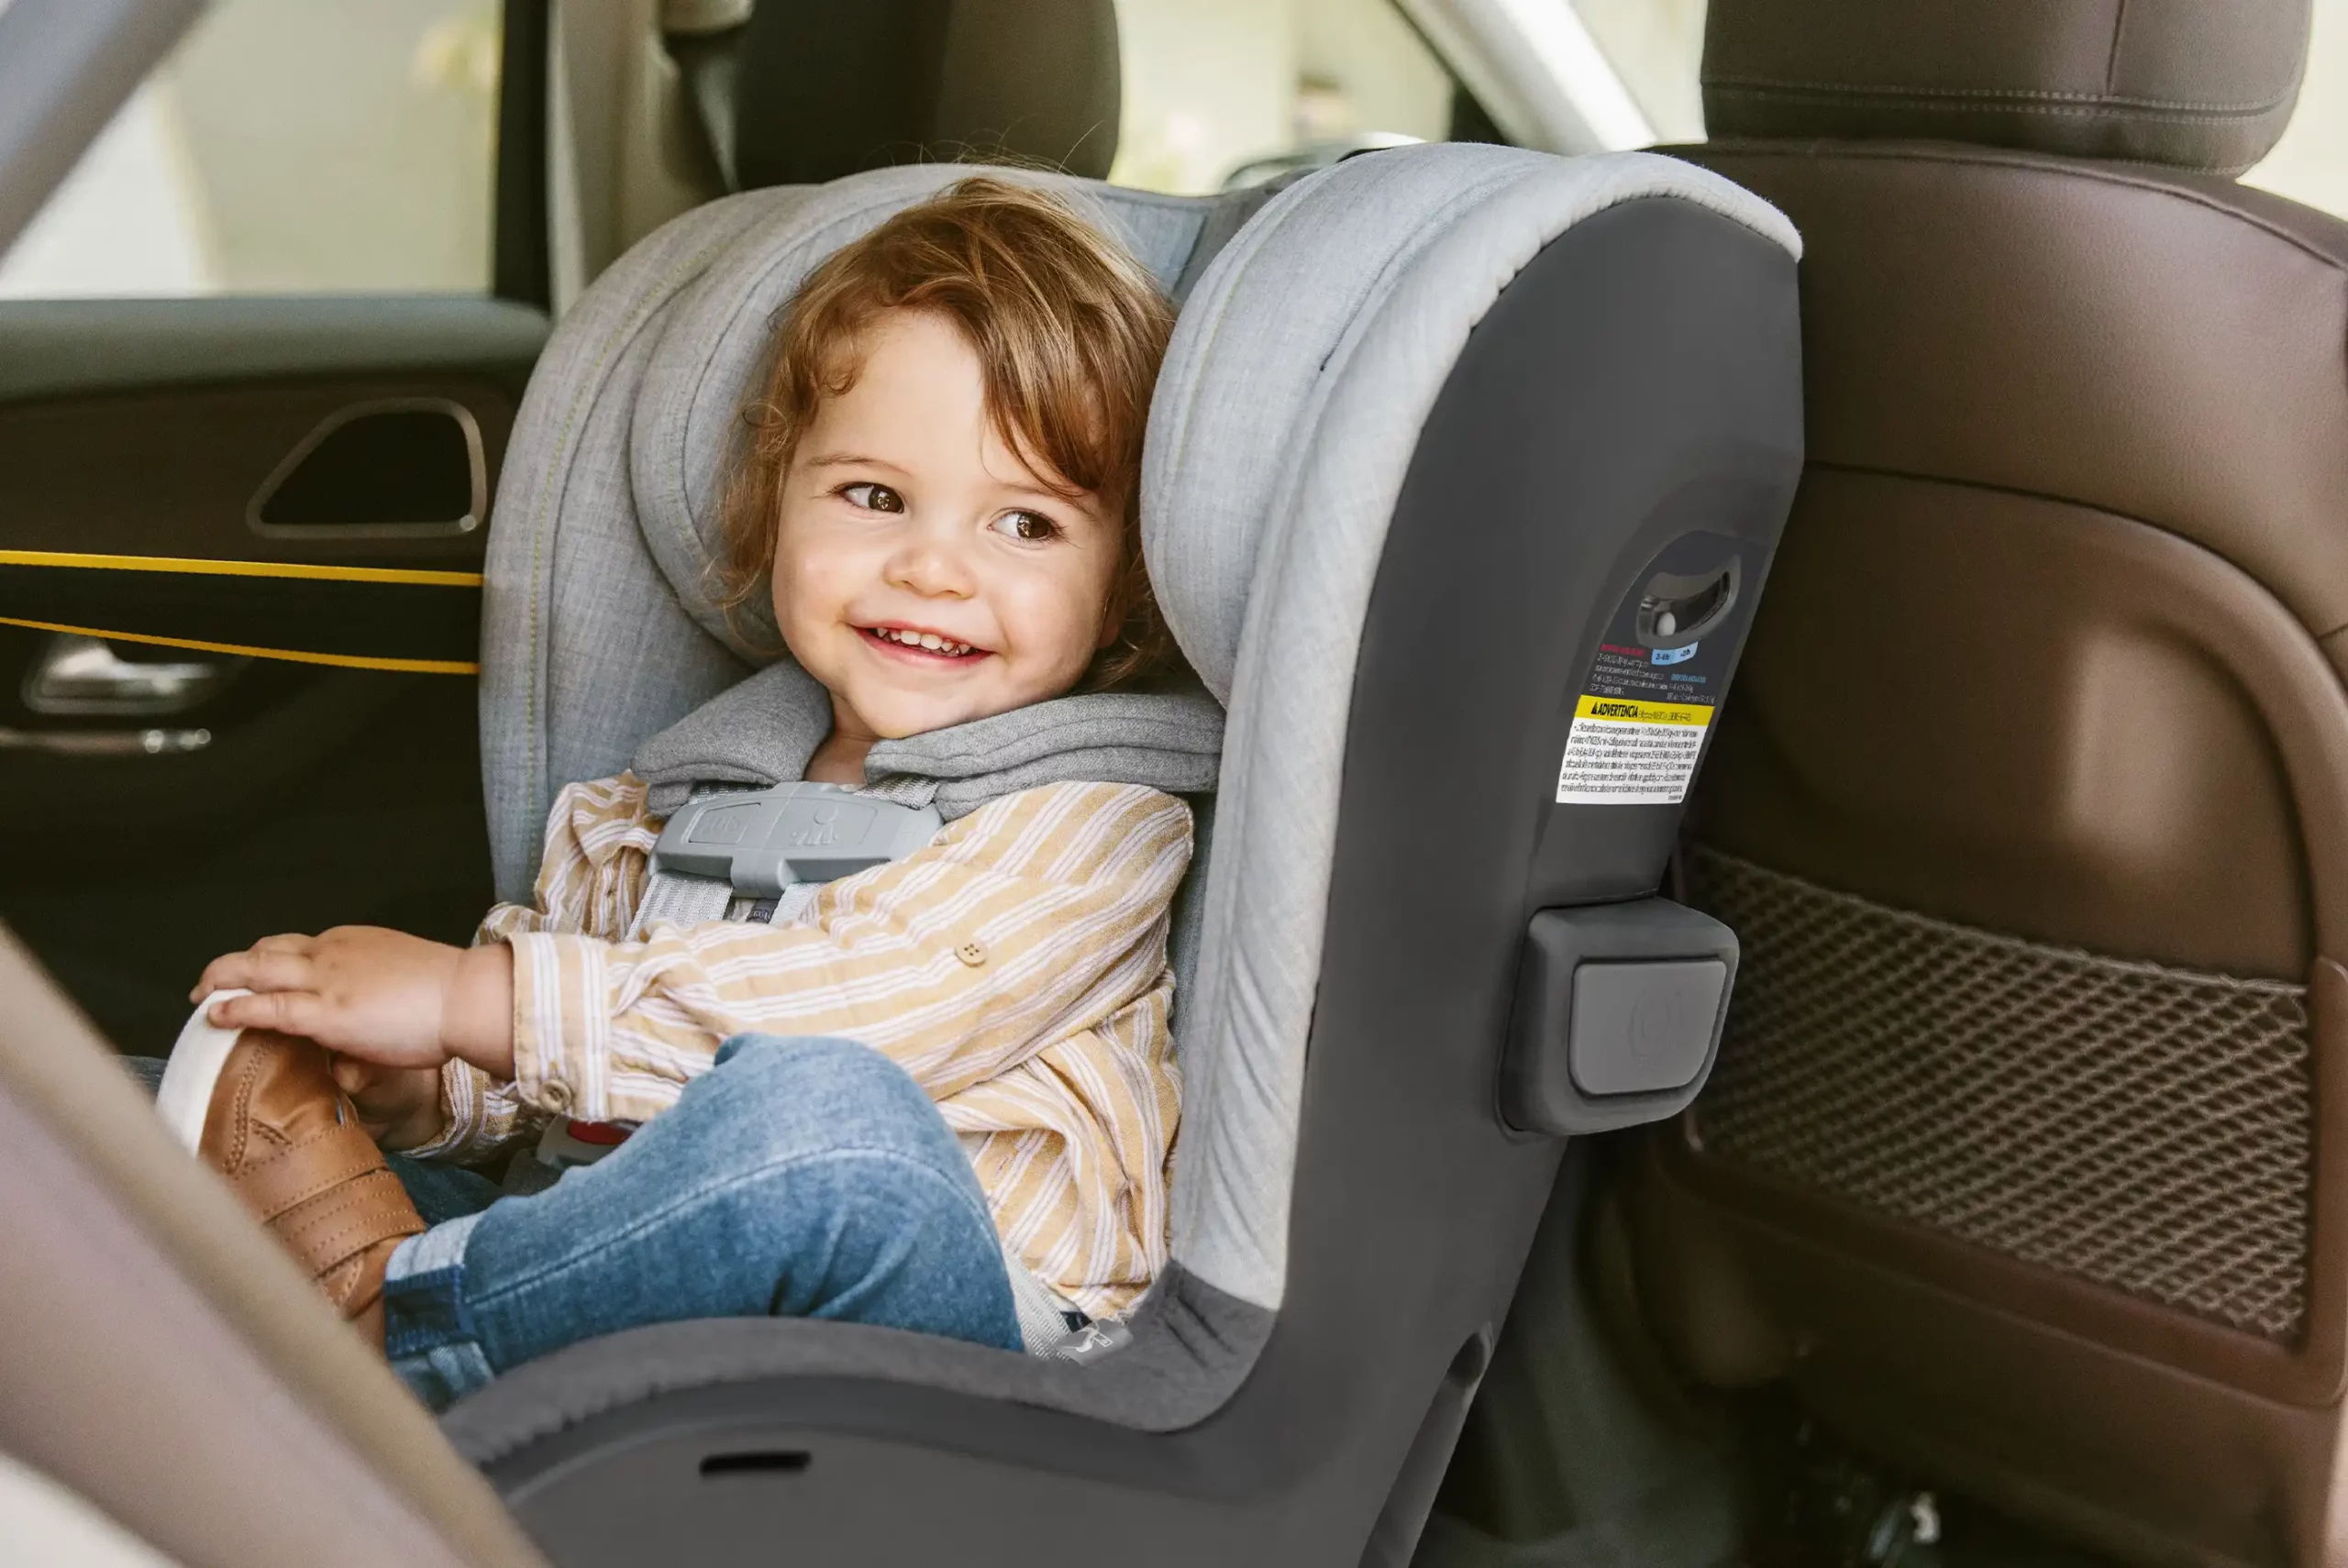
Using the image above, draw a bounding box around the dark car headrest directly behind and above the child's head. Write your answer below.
[730,0,1120,190]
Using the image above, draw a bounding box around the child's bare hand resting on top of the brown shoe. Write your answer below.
[188,925,515,1077]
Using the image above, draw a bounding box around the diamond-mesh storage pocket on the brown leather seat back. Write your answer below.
[1686,847,2315,1341]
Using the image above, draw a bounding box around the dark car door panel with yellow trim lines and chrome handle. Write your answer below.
[0,296,547,1052]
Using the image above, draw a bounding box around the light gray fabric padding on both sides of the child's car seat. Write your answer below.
[482,143,1799,1309]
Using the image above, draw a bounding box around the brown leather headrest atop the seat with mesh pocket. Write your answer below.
[1705,0,2310,173]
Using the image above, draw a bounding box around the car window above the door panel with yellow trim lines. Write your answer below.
[0,0,500,298]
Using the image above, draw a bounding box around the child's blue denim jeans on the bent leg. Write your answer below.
[382,1035,1019,1408]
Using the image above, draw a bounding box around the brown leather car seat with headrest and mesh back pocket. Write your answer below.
[1627,0,2348,1563]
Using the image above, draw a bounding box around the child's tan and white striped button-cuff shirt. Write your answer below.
[411,775,1191,1317]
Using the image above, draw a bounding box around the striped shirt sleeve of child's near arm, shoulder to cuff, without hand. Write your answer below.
[488,784,1191,1122]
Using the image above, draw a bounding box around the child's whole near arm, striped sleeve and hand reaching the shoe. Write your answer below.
[200,784,1191,1141]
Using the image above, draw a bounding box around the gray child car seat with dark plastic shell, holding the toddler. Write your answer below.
[444,146,1801,1568]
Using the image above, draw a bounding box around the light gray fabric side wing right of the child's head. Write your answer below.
[1141,143,1801,1308]
